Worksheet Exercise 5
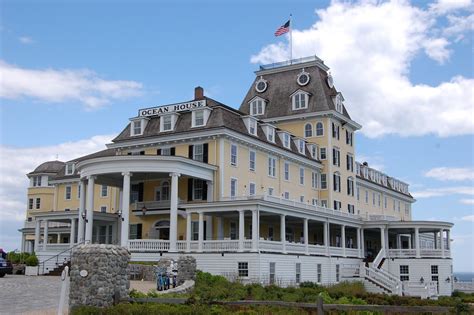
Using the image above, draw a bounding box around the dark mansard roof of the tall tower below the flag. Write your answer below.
[240,59,351,119]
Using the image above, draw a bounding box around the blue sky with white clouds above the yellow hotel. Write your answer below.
[0,0,474,271]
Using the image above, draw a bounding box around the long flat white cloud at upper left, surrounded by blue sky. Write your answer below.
[0,60,142,109]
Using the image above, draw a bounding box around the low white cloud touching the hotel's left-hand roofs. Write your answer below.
[0,135,113,221]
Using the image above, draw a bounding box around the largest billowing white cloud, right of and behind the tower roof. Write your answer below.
[251,1,474,137]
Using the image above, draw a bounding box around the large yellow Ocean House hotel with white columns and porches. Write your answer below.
[21,57,453,297]
